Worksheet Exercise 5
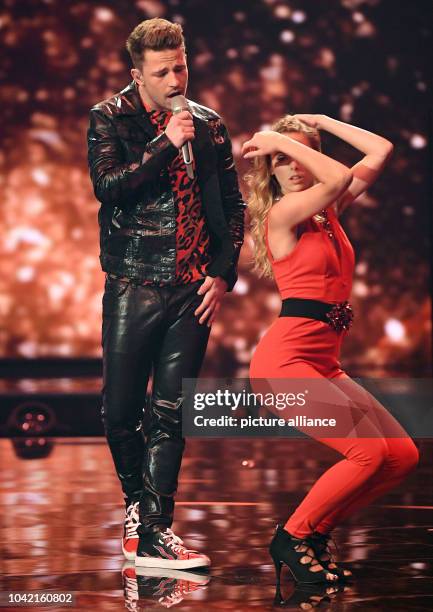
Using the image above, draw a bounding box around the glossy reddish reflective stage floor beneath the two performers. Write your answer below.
[0,438,433,612]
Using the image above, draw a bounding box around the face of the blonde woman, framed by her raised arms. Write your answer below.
[271,132,314,195]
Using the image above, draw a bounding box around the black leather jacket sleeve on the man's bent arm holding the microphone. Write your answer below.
[87,108,178,209]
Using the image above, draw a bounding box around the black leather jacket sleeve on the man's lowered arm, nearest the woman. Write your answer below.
[216,122,245,291]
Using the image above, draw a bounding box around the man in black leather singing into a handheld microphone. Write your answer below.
[88,19,245,569]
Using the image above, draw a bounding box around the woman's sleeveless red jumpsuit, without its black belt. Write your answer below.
[250,206,418,538]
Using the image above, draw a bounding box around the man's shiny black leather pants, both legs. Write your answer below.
[101,276,210,534]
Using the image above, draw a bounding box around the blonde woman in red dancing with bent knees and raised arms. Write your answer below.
[242,115,418,584]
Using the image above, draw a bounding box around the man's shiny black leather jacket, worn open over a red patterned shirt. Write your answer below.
[87,81,245,291]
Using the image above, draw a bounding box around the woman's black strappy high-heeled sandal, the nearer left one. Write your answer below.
[269,525,338,590]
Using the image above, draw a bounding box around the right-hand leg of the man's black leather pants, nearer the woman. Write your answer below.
[138,281,210,534]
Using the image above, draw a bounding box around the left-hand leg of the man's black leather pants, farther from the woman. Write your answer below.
[101,277,164,503]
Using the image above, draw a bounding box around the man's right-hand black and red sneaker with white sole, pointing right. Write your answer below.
[135,528,210,569]
